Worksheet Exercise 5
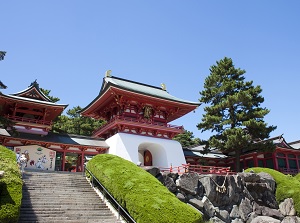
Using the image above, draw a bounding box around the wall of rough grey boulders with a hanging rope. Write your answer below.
[146,167,300,223]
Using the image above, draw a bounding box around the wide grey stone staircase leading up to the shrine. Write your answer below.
[19,172,122,223]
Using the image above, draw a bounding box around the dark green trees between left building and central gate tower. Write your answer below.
[53,106,105,136]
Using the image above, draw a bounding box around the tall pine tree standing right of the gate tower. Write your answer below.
[197,57,276,171]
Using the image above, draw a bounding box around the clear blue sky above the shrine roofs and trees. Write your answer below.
[0,0,300,142]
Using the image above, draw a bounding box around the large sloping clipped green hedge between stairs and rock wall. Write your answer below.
[87,154,202,223]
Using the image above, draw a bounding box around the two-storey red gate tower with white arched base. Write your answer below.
[81,71,200,167]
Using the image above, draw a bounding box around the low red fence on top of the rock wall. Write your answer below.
[160,164,236,175]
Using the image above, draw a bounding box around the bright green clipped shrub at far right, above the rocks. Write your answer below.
[246,167,300,216]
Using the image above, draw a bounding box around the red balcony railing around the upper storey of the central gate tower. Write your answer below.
[93,115,183,134]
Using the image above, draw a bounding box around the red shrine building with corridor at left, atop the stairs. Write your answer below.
[0,81,108,171]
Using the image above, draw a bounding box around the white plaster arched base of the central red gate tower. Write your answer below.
[106,133,186,168]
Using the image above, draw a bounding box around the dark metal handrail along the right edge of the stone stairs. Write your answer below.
[85,166,136,223]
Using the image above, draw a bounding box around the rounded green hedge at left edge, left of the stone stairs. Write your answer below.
[0,146,22,223]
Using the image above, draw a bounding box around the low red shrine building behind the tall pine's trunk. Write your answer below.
[183,135,300,174]
